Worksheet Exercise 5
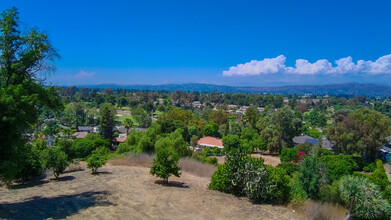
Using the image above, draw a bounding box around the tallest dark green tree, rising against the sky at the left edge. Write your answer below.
[0,8,63,182]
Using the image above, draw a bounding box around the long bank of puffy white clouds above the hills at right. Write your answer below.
[223,54,391,76]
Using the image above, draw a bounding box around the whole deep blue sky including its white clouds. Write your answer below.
[0,0,391,86]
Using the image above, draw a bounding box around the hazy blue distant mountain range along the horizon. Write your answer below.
[77,83,391,97]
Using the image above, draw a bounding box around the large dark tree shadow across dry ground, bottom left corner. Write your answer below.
[0,191,114,220]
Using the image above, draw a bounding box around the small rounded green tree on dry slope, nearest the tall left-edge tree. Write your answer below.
[42,147,69,179]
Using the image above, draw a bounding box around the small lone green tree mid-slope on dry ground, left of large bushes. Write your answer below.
[150,146,181,183]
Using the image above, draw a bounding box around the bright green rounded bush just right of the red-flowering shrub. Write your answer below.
[319,154,358,183]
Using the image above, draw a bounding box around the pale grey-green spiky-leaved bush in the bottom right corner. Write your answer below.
[339,176,391,219]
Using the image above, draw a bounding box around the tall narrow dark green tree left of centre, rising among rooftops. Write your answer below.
[100,103,115,142]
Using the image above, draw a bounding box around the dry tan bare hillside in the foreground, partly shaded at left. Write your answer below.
[0,166,300,220]
